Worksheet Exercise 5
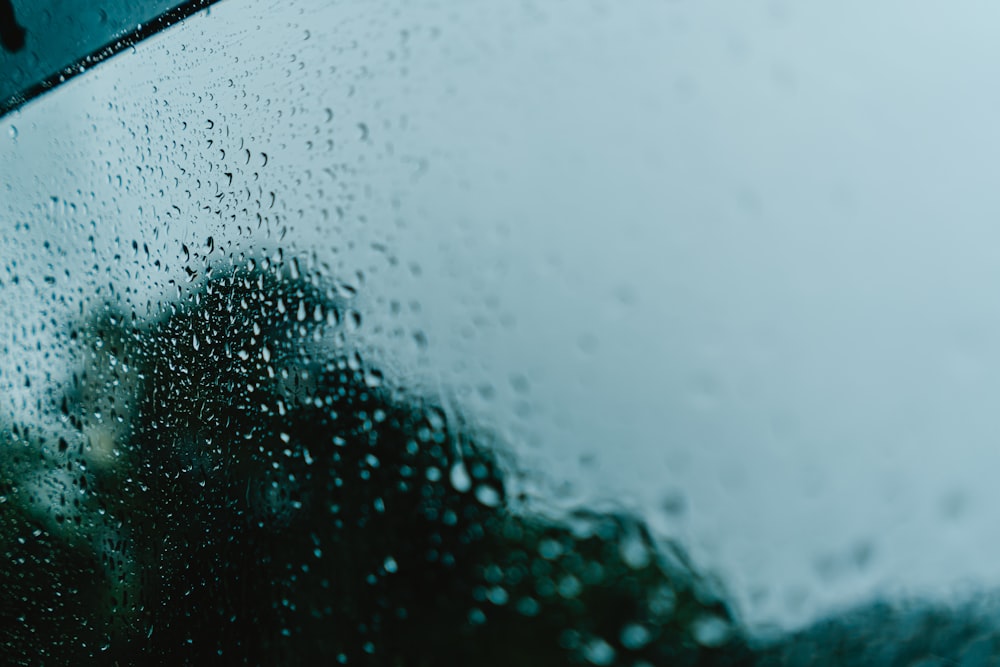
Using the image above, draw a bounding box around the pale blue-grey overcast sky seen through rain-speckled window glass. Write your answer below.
[0,0,1000,636]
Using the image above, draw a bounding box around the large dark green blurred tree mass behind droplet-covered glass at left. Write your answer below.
[0,261,750,666]
